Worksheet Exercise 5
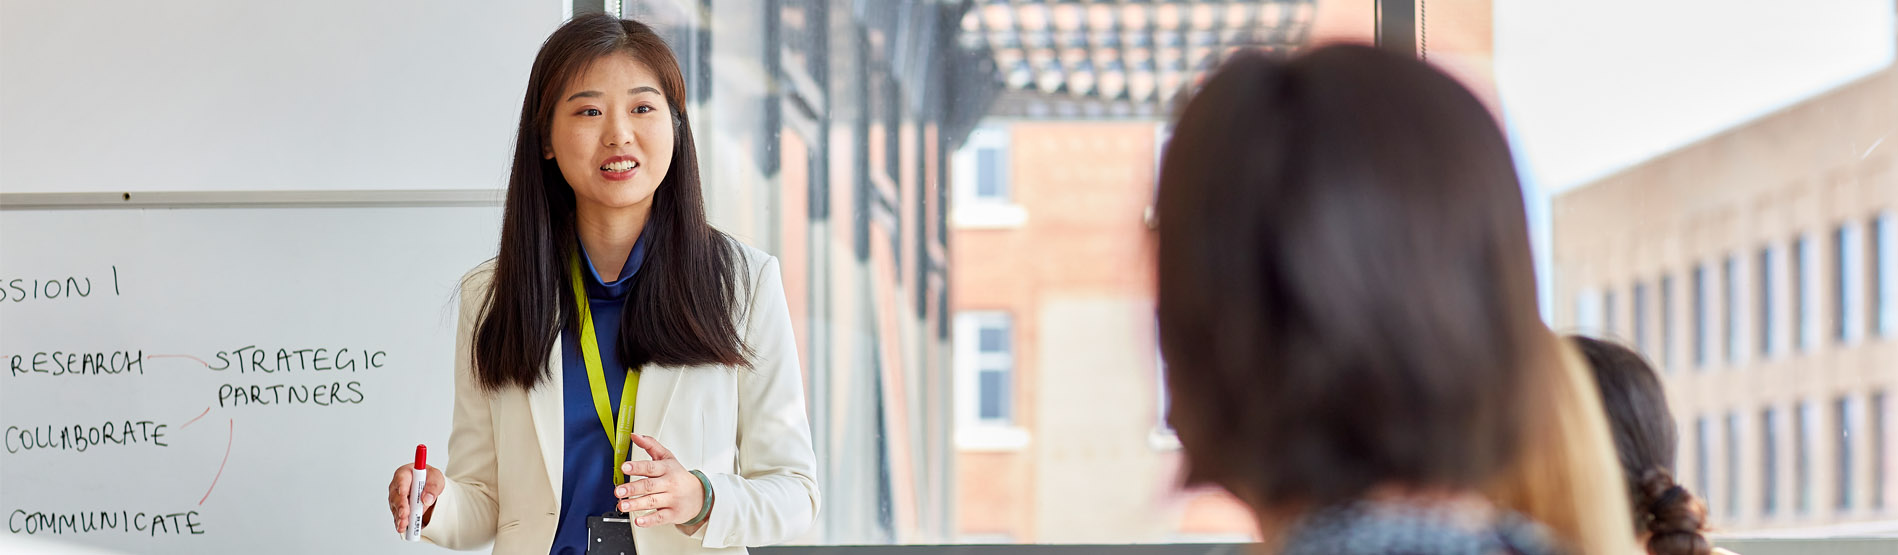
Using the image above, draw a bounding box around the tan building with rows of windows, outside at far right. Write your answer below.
[1553,23,1898,532]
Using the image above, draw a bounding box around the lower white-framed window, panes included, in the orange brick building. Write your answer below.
[955,312,1027,449]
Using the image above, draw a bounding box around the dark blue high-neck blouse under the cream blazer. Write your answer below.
[550,232,645,555]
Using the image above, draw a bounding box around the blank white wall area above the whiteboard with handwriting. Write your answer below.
[0,0,564,192]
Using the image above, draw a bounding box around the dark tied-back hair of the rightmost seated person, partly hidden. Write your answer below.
[1570,335,1714,555]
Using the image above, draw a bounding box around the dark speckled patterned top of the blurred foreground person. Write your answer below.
[1281,502,1566,555]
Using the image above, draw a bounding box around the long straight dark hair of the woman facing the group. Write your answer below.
[475,13,750,392]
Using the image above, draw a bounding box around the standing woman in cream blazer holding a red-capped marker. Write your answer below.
[389,13,818,553]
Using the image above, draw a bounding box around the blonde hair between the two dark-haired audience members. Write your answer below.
[1490,333,1644,553]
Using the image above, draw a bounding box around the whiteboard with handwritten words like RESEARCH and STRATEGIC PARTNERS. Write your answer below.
[0,196,501,553]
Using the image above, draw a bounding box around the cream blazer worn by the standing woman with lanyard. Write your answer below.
[421,245,818,553]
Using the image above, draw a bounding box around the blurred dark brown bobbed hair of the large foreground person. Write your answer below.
[1158,46,1556,507]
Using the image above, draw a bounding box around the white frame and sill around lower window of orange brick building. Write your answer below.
[953,310,1029,450]
